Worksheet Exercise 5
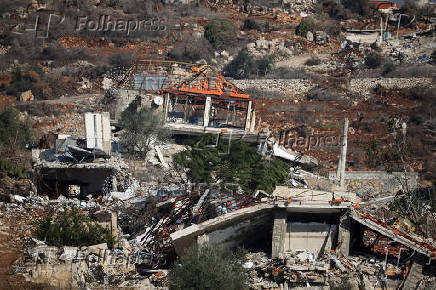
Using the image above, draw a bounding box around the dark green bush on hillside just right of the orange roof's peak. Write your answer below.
[224,49,273,79]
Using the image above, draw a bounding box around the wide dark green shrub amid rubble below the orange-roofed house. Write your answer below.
[174,135,289,193]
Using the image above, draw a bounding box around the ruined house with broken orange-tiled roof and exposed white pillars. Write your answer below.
[111,60,266,143]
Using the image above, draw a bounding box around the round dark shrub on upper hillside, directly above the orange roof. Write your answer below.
[204,19,238,49]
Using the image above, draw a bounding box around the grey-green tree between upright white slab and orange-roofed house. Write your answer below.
[120,107,169,159]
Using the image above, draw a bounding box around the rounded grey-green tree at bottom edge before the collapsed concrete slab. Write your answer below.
[168,245,248,290]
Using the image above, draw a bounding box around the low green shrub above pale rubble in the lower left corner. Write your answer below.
[35,208,114,248]
